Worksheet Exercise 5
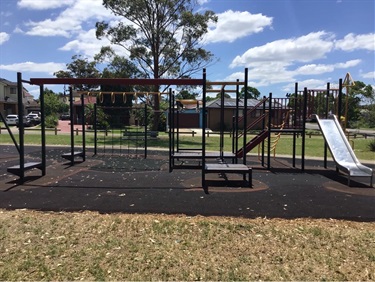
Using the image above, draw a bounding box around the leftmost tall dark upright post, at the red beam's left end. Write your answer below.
[17,72,25,182]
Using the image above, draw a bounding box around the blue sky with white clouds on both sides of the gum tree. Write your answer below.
[0,0,375,98]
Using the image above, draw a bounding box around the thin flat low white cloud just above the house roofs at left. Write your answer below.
[0,62,66,75]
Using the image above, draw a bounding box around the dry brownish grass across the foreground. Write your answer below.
[0,210,375,280]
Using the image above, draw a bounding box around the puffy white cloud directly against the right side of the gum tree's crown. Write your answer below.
[204,10,272,43]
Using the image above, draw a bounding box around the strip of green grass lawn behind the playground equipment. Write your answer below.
[0,128,375,160]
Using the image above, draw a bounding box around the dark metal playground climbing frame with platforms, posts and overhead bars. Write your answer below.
[4,69,372,193]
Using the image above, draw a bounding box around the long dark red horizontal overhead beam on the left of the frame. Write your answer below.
[30,78,204,85]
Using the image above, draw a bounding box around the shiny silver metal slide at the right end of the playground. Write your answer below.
[316,115,373,187]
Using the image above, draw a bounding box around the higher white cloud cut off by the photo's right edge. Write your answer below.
[335,33,375,51]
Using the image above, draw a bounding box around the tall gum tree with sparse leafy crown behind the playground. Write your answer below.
[96,0,217,130]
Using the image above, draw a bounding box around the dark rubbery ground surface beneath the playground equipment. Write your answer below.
[0,145,375,221]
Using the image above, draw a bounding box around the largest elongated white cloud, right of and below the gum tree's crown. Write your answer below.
[230,31,333,68]
